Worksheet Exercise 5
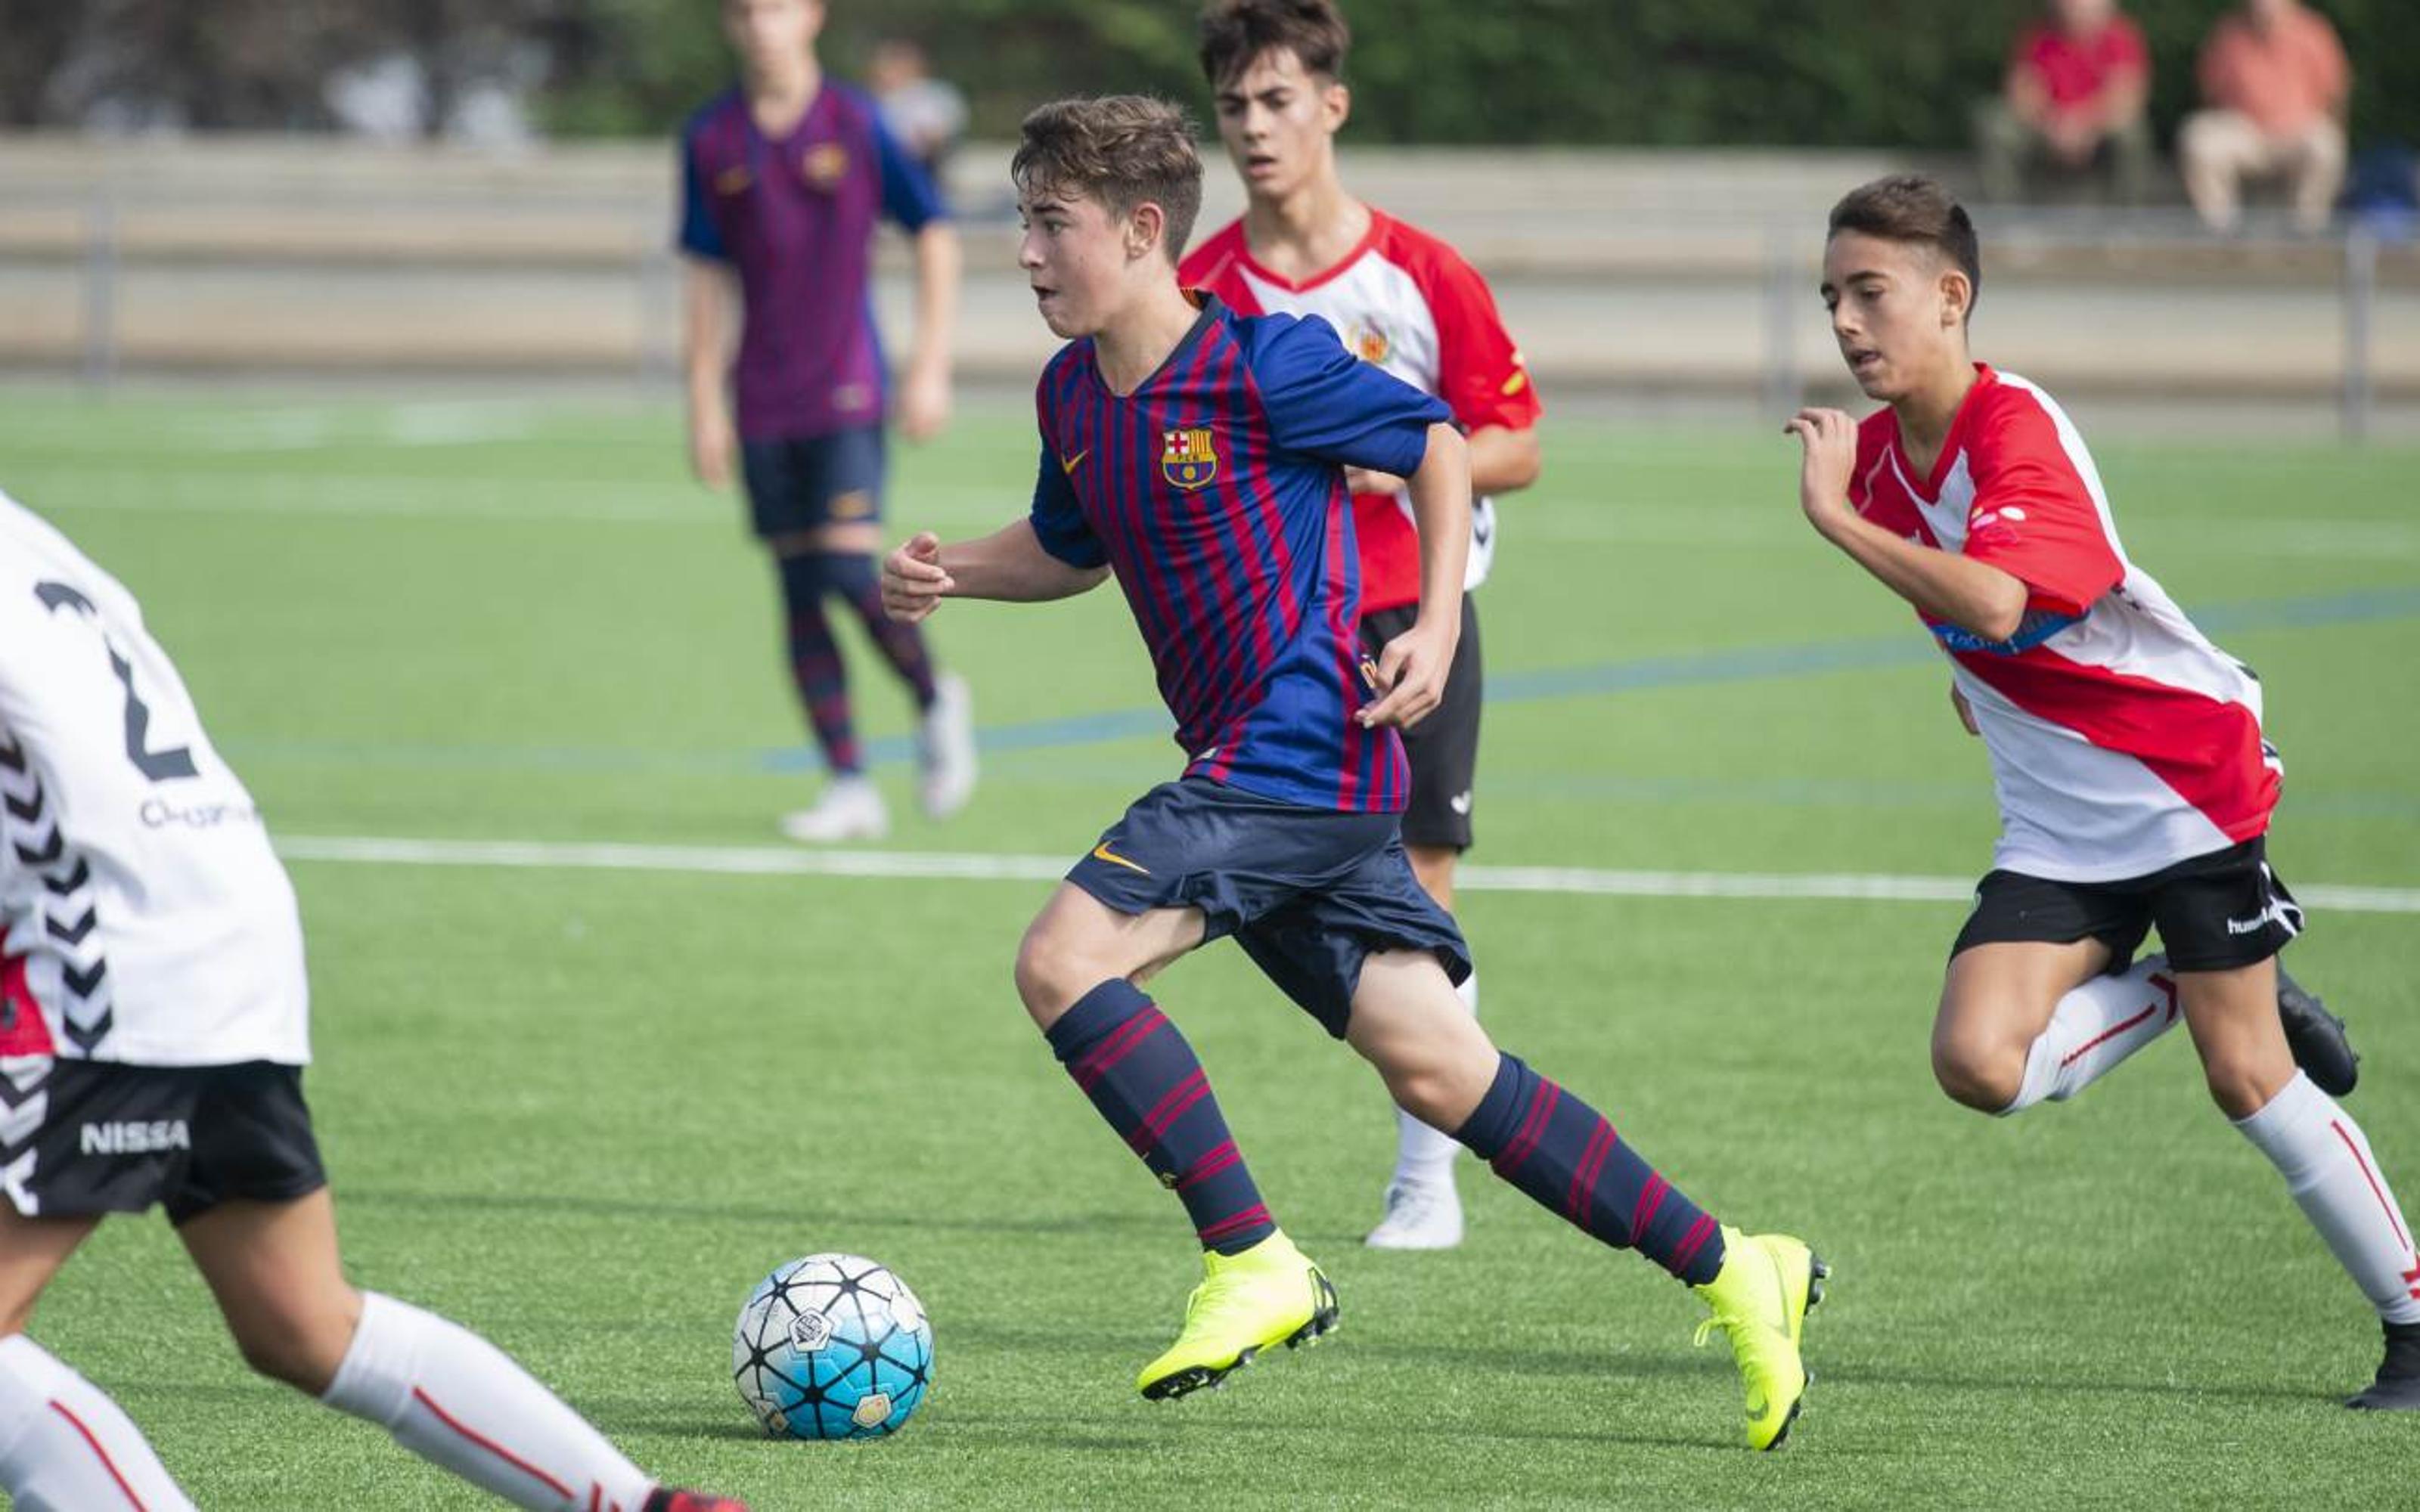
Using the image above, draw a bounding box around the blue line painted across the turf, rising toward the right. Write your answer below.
[228,585,2420,774]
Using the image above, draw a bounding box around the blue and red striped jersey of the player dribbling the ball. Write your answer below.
[1033,298,1452,813]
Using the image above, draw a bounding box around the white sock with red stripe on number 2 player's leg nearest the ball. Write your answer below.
[319,1292,656,1512]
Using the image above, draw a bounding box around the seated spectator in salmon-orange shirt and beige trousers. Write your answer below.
[2176,0,2352,232]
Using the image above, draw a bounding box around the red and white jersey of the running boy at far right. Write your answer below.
[1849,363,2282,883]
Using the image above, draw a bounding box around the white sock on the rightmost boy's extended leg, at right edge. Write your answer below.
[2236,1072,2420,1323]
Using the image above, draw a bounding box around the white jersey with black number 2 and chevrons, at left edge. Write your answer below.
[0,494,310,1067]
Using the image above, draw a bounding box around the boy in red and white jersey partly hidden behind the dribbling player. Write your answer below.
[1178,0,1539,1248]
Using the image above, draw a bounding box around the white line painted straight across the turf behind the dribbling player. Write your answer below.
[278,835,2420,915]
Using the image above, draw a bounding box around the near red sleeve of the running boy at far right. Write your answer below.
[1965,389,2125,615]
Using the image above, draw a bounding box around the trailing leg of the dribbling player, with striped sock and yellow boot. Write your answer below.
[1345,951,1823,1449]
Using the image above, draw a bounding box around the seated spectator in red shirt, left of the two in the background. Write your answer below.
[1975,0,2152,203]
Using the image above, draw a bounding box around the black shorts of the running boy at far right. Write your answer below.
[1950,835,2301,970]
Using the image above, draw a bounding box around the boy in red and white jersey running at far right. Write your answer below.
[1789,177,2420,1411]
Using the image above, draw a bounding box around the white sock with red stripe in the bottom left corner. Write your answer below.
[0,1333,194,1512]
